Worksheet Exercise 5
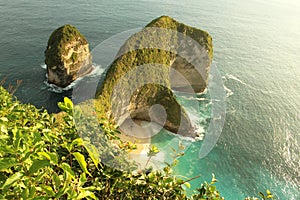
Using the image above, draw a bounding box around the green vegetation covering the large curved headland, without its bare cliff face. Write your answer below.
[96,16,217,137]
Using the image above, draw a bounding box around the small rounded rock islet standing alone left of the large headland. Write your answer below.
[45,25,92,87]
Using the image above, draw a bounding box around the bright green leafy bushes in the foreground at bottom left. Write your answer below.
[0,86,272,200]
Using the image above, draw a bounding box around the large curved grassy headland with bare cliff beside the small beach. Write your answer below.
[96,16,212,137]
